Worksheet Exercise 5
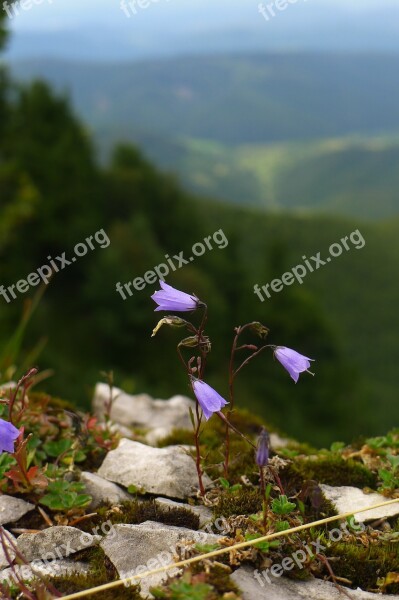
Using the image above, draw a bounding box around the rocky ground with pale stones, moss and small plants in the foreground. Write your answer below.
[0,384,399,600]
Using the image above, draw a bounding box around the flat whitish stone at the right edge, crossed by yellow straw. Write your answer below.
[320,484,399,523]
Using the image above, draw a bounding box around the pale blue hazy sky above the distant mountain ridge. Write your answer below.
[6,0,399,61]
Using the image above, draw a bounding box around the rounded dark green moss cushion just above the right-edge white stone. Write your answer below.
[281,454,377,489]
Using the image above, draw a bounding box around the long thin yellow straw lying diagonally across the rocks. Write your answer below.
[63,498,399,600]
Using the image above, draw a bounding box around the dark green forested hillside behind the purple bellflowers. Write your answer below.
[0,79,399,442]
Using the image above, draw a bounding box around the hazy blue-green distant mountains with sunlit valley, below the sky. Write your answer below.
[12,53,399,218]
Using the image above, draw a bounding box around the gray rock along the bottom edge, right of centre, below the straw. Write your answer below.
[231,567,399,600]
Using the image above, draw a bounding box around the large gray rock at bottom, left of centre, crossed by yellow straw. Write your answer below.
[100,521,220,595]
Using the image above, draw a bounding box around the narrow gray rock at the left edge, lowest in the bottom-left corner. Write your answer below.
[0,559,90,583]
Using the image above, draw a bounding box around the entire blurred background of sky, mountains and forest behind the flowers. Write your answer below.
[0,0,399,445]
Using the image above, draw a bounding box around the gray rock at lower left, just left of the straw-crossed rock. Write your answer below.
[17,525,101,562]
